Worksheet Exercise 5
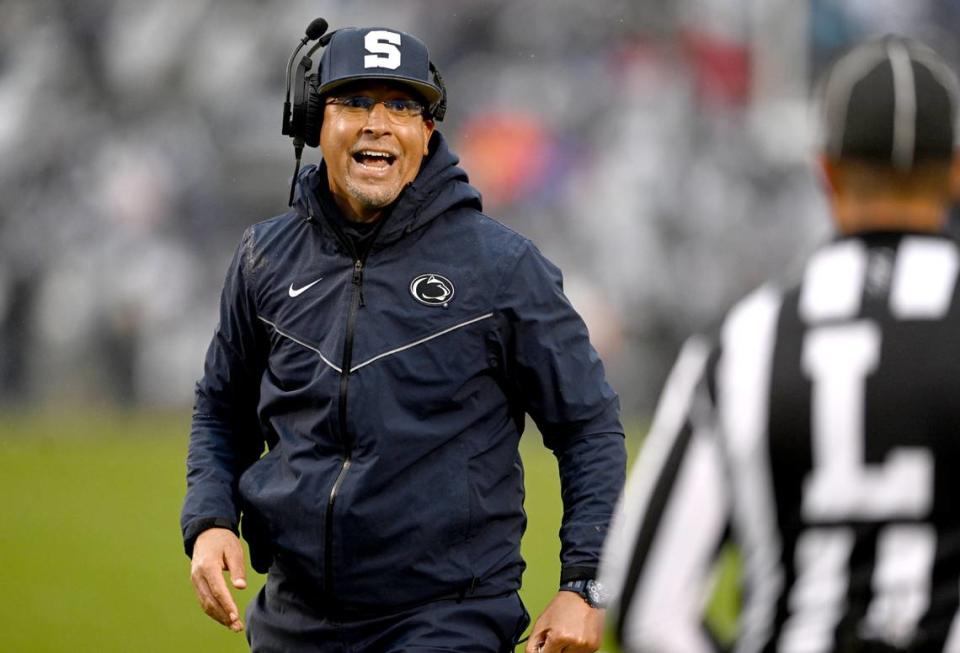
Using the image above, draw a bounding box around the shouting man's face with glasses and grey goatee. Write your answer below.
[320,82,434,222]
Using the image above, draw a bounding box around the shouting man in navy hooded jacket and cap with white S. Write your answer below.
[181,22,625,652]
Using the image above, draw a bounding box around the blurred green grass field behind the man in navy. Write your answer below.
[0,411,660,653]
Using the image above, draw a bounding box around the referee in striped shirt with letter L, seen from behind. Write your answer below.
[601,36,960,653]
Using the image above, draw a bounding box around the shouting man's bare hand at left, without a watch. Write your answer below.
[190,528,247,633]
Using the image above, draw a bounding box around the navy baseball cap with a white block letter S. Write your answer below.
[317,27,444,110]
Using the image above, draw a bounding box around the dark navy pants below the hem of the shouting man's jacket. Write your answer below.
[246,574,530,653]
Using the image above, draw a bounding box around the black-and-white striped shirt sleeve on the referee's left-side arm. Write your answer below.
[600,340,730,653]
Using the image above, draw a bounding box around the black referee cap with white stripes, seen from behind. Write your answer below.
[823,36,960,171]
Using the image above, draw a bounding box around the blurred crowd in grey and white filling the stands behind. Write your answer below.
[0,0,960,415]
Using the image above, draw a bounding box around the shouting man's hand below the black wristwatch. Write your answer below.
[525,592,604,653]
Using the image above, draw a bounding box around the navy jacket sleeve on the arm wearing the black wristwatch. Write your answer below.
[504,241,626,582]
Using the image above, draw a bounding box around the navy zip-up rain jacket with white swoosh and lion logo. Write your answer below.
[181,133,625,613]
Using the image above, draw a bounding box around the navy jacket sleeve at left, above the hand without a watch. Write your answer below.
[180,228,268,556]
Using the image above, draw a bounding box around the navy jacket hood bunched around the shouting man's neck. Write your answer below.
[293,131,482,243]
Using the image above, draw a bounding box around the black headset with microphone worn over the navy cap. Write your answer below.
[281,18,447,206]
